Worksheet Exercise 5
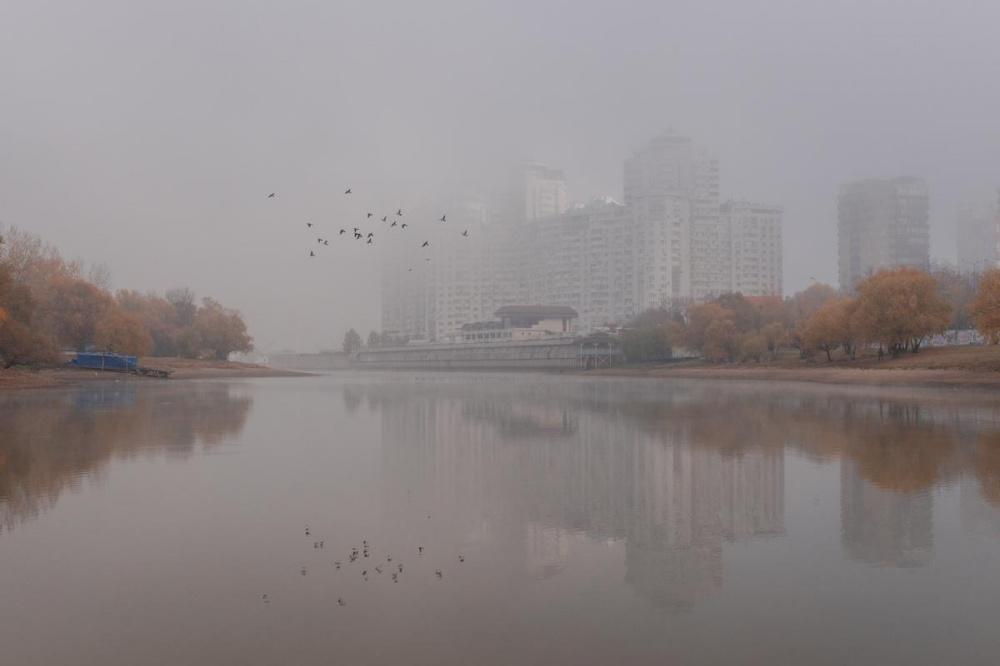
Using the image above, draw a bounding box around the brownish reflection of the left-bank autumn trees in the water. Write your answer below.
[0,383,252,529]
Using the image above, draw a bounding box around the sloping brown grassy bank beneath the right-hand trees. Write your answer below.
[587,346,1000,389]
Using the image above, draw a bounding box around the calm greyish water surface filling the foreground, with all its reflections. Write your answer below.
[0,374,1000,666]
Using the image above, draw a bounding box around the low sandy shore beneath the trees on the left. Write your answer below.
[0,358,312,391]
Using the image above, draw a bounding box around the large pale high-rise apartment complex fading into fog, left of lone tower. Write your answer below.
[382,132,782,342]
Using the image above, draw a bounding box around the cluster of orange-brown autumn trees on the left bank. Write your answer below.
[0,229,253,368]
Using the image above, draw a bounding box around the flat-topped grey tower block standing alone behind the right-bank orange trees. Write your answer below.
[838,178,930,289]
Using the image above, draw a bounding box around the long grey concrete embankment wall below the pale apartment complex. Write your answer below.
[354,340,580,370]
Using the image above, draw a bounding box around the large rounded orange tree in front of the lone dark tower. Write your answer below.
[852,267,951,356]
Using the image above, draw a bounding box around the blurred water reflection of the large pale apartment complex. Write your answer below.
[369,378,784,610]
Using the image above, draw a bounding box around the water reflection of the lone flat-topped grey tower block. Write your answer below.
[840,457,934,567]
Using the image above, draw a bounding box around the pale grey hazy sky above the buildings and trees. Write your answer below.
[0,0,1000,349]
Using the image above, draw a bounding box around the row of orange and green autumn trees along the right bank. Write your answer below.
[622,267,1000,362]
